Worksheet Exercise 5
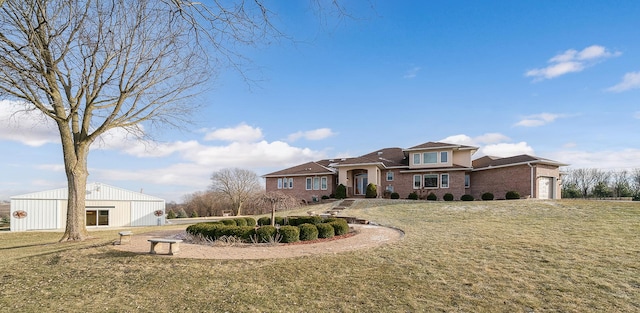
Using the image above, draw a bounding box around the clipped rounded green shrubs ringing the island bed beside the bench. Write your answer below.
[187,216,349,243]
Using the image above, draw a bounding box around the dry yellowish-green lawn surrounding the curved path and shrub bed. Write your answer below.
[0,200,640,312]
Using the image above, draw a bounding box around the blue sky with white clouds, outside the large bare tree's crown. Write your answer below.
[0,1,640,202]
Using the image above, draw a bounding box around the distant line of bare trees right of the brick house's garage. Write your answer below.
[562,168,640,201]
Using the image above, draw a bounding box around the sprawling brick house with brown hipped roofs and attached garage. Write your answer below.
[262,142,567,201]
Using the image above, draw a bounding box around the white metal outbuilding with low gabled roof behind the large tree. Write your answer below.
[11,183,165,231]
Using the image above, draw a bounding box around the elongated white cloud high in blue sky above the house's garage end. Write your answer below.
[525,45,622,81]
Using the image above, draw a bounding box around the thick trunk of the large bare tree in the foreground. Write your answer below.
[60,125,89,242]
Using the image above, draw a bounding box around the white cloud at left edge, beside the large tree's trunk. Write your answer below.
[0,100,60,147]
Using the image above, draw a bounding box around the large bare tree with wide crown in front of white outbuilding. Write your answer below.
[0,0,284,241]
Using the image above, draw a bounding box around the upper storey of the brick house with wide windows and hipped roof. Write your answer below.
[404,142,478,169]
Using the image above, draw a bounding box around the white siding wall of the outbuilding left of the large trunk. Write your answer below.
[11,199,61,231]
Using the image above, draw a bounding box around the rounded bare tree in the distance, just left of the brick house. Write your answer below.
[211,168,263,215]
